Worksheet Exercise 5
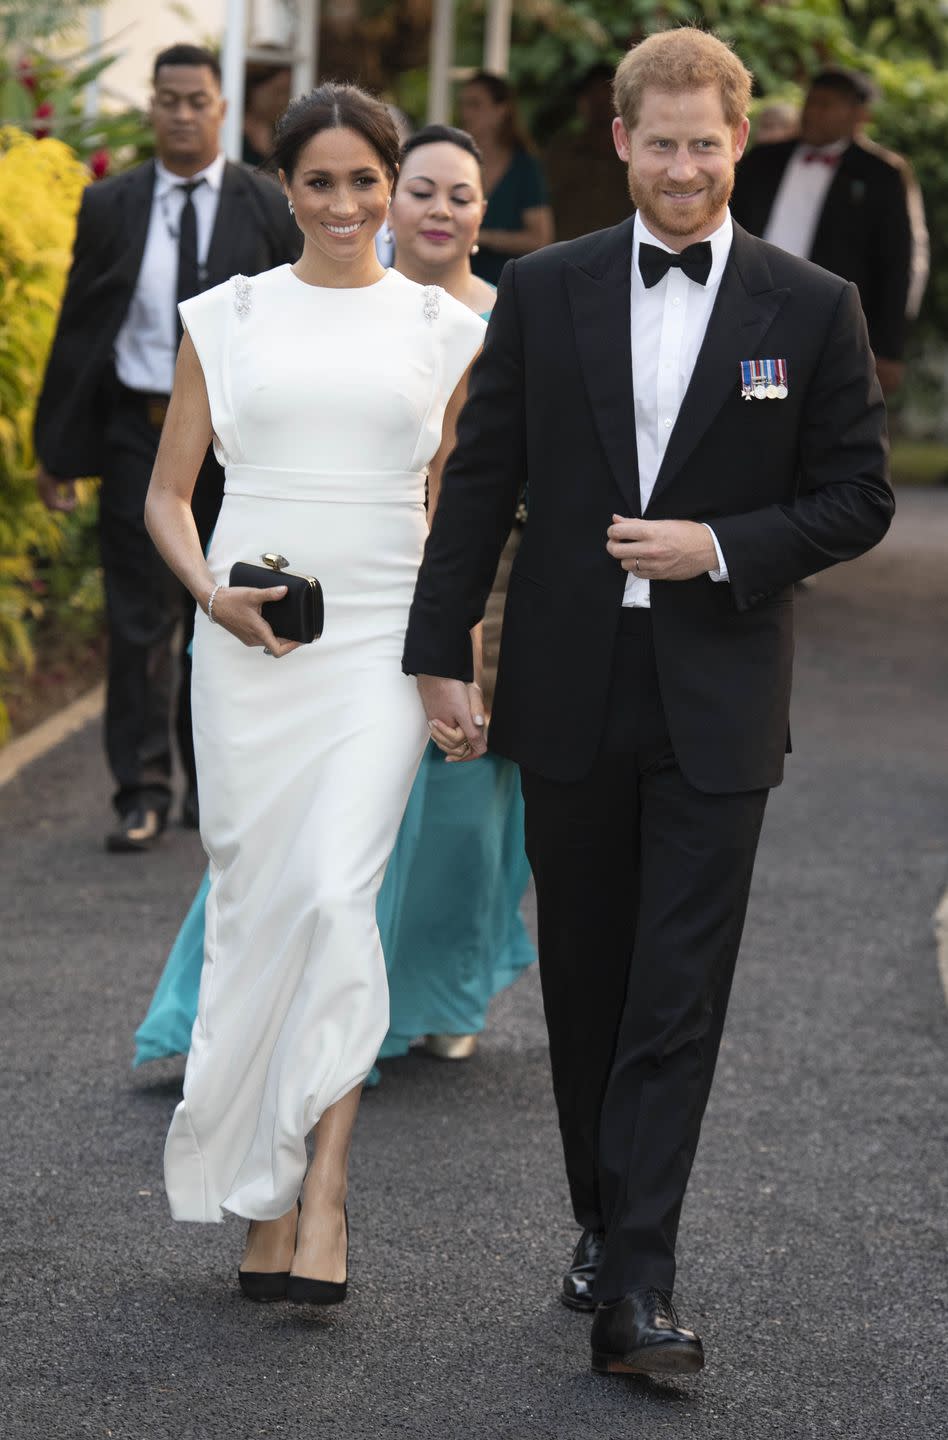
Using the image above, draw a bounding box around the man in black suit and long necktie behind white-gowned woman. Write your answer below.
[36,45,300,851]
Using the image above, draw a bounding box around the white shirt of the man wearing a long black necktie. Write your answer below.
[115,154,228,395]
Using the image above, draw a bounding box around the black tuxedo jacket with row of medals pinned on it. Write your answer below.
[403,220,893,792]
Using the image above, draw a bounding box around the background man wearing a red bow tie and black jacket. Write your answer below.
[732,69,925,393]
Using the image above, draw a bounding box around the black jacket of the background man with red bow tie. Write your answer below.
[730,140,912,360]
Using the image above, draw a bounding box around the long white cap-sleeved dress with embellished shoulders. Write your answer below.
[164,265,484,1221]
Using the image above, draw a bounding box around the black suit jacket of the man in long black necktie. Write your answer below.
[35,160,296,478]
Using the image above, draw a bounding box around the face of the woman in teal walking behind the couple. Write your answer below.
[389,141,487,271]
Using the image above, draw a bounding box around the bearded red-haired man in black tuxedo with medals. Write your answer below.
[403,29,893,1374]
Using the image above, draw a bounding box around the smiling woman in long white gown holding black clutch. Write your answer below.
[146,85,484,1303]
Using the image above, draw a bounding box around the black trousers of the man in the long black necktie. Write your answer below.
[99,384,223,816]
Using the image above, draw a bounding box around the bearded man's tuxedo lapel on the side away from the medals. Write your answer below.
[566,220,641,517]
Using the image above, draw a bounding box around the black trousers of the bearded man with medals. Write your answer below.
[522,611,768,1300]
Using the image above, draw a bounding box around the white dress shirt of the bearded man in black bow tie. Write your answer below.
[622,210,733,609]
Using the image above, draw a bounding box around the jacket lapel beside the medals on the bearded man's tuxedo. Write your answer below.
[648,225,790,507]
